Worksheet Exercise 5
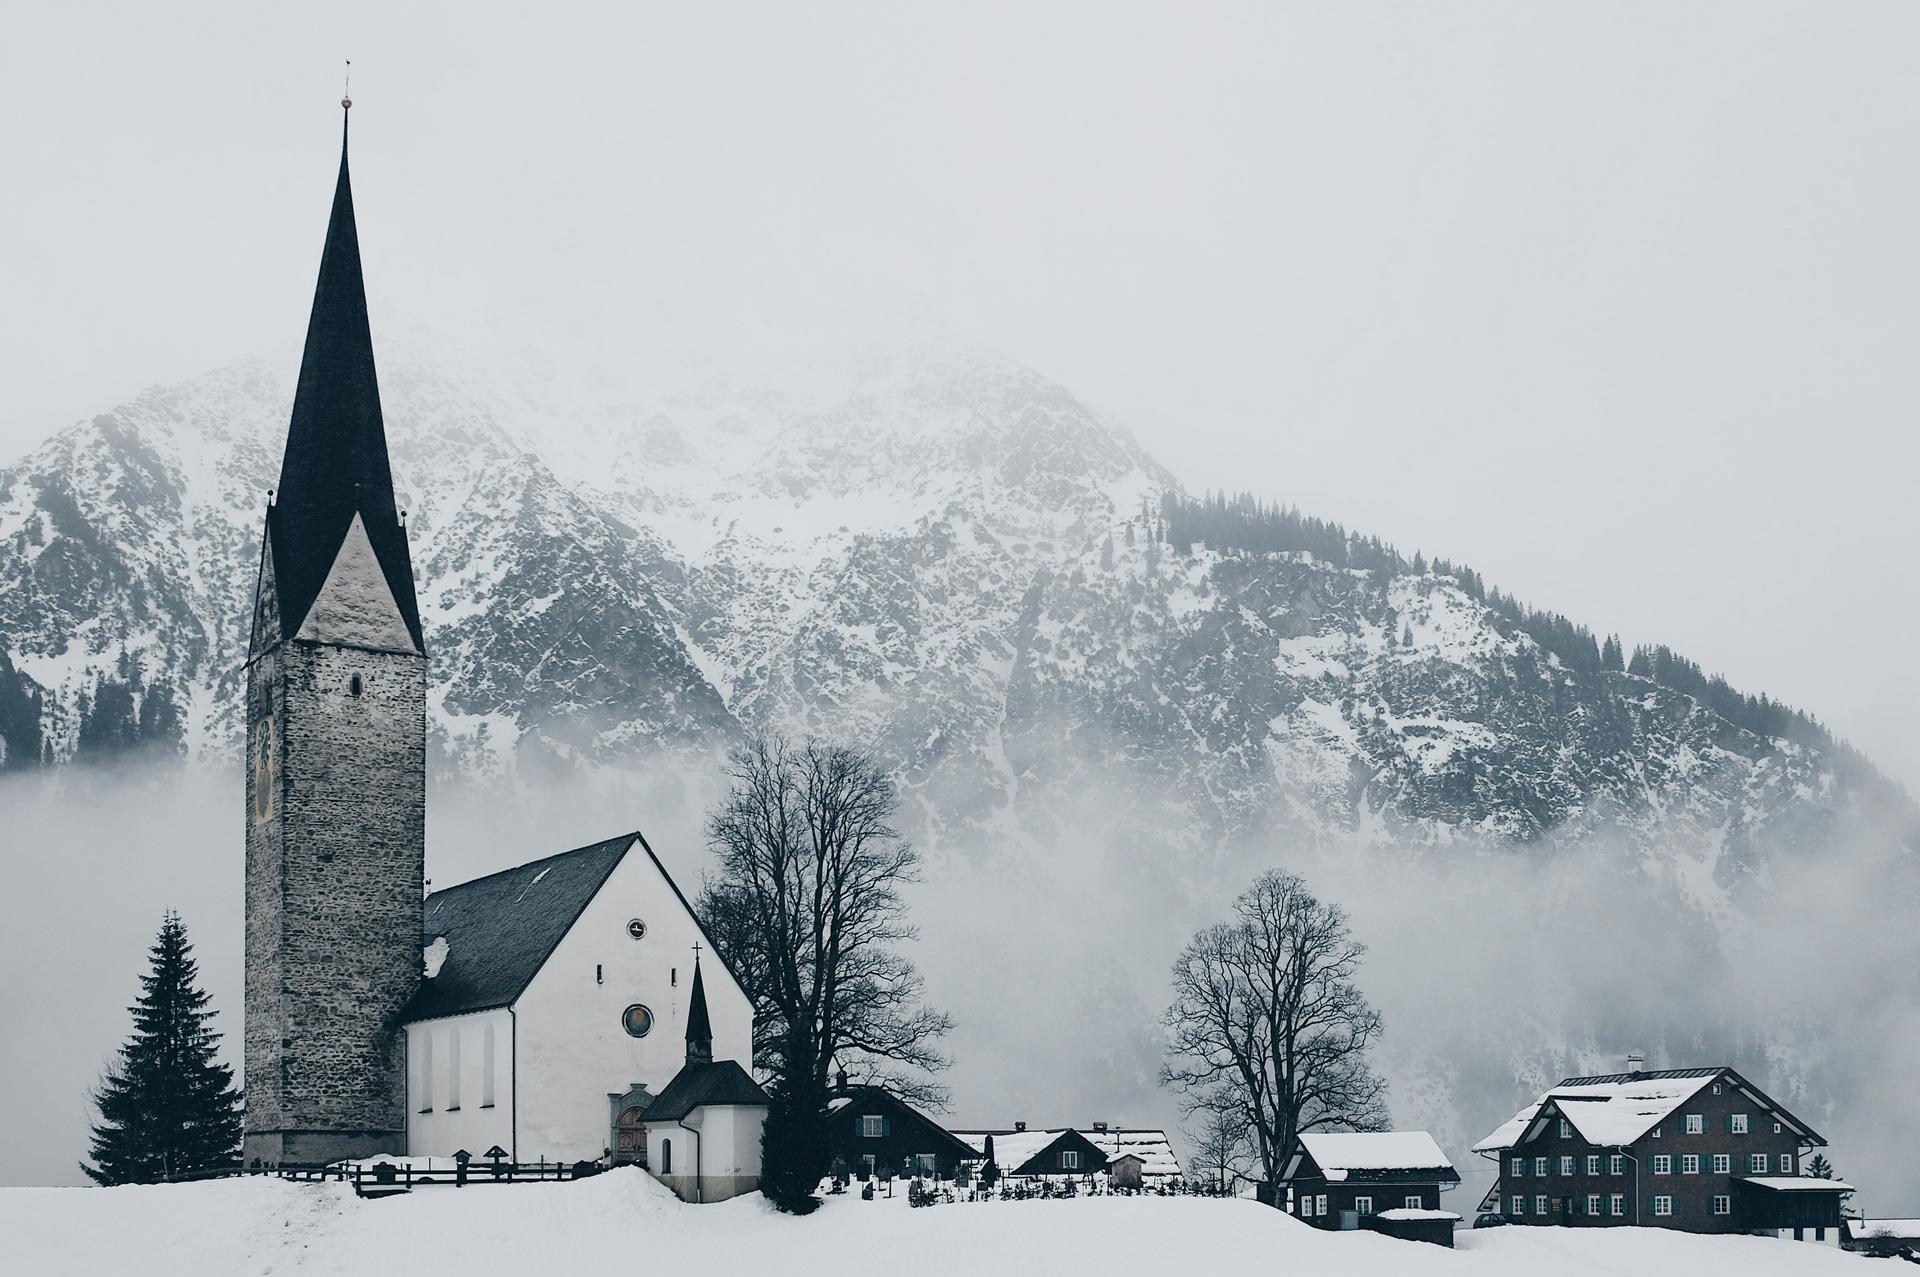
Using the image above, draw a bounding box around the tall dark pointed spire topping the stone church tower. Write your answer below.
[267,98,424,651]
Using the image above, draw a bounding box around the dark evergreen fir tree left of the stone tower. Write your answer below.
[81,912,240,1185]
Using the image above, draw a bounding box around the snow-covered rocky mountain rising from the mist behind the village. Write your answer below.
[0,344,1920,1182]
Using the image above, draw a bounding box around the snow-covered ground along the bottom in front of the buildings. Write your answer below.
[0,1171,1884,1277]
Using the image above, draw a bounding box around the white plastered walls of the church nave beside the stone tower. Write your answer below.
[407,841,760,1175]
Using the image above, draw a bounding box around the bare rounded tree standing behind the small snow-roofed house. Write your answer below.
[1162,870,1386,1185]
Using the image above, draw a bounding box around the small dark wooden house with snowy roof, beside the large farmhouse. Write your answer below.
[1281,1131,1459,1246]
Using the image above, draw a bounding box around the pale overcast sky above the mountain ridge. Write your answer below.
[0,0,1920,789]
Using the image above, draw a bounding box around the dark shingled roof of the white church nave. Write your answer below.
[403,833,639,1022]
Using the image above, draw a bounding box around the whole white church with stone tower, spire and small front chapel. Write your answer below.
[244,100,766,1200]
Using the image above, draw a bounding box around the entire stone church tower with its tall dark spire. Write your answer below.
[244,102,426,1164]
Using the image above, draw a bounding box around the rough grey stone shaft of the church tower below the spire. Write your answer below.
[246,639,426,1162]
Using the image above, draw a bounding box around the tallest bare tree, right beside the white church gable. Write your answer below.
[701,737,952,1208]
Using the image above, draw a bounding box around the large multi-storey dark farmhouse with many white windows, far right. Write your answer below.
[1475,1066,1849,1241]
